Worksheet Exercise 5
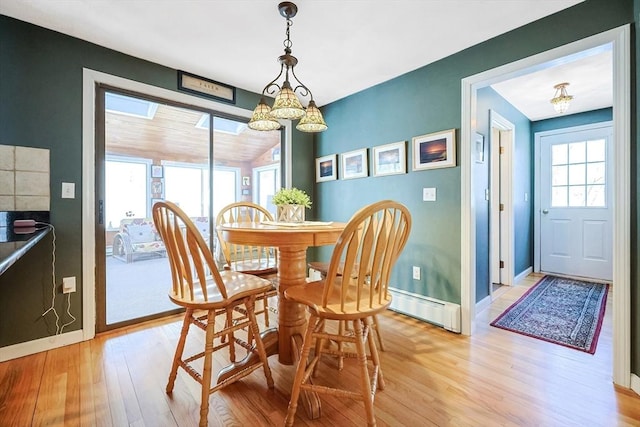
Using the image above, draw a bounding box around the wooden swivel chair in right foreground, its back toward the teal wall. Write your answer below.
[285,200,411,426]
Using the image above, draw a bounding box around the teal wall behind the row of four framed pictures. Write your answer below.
[315,0,640,373]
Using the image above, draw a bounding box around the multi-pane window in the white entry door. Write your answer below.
[551,139,607,208]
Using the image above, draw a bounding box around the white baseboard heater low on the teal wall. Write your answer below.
[389,288,460,333]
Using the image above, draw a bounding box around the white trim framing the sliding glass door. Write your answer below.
[79,68,292,344]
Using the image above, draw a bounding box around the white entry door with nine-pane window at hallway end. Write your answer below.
[536,123,613,280]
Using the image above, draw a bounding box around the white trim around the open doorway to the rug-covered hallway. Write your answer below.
[460,25,631,388]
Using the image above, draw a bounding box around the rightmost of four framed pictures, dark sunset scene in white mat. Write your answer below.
[413,129,456,171]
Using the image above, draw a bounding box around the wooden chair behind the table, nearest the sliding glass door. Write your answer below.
[216,202,278,327]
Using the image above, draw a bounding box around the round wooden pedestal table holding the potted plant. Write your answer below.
[219,221,346,365]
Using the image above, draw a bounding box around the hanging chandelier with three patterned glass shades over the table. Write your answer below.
[249,1,327,132]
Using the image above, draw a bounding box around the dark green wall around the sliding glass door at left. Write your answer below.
[0,16,314,347]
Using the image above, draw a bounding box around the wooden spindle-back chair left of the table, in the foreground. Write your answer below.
[153,201,273,427]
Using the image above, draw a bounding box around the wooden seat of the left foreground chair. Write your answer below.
[169,270,273,310]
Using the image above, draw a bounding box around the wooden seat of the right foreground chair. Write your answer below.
[284,278,391,320]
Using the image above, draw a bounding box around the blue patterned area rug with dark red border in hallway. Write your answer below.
[491,276,609,354]
